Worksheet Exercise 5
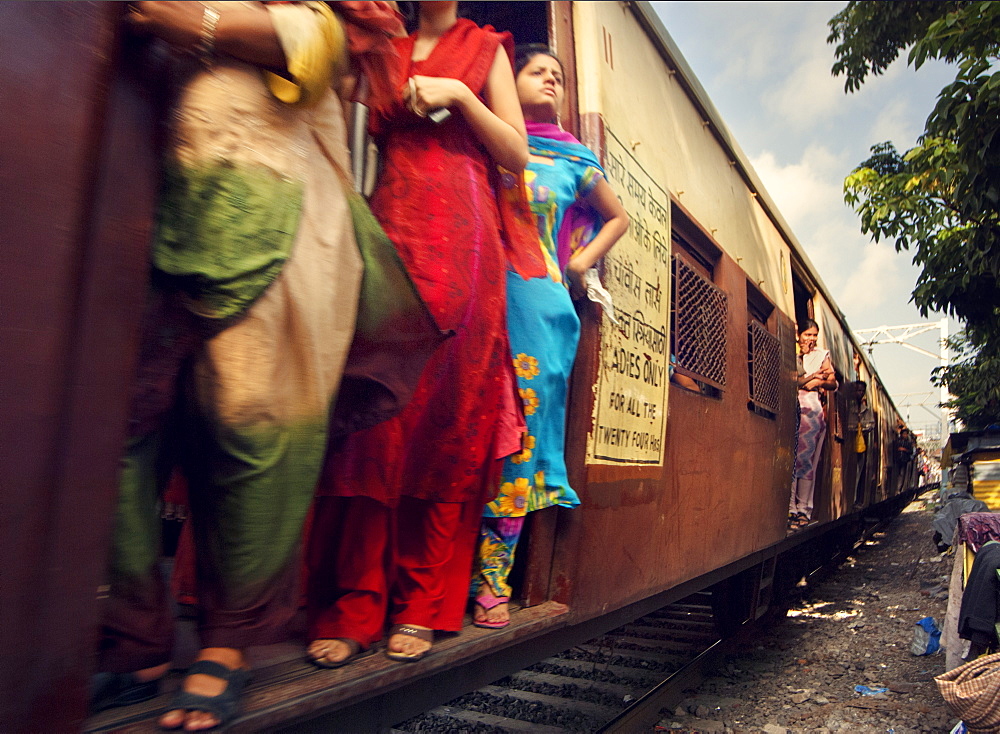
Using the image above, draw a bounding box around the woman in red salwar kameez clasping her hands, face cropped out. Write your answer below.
[307,2,544,667]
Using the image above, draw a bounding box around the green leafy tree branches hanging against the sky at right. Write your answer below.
[827,0,1000,432]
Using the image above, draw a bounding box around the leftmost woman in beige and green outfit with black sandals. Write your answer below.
[91,2,397,731]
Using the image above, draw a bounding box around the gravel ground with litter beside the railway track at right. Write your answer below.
[656,500,958,734]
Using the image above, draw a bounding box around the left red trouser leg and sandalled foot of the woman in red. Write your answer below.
[306,497,392,664]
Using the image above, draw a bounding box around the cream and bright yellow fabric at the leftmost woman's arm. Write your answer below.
[264,2,347,107]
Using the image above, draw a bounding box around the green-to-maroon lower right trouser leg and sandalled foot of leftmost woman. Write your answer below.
[160,396,325,731]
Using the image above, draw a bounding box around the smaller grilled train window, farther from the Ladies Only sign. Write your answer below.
[747,281,781,420]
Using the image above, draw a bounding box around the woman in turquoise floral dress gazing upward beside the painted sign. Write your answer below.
[472,46,628,629]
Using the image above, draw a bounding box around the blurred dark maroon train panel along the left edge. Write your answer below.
[0,3,155,731]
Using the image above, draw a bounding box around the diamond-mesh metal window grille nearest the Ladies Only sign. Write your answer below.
[673,256,728,388]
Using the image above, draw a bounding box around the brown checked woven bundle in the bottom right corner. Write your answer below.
[934,653,1000,734]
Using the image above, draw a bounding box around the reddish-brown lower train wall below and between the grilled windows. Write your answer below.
[553,244,796,617]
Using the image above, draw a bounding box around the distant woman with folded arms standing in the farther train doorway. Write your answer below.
[788,319,837,530]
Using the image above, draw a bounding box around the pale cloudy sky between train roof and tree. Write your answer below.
[651,2,957,440]
